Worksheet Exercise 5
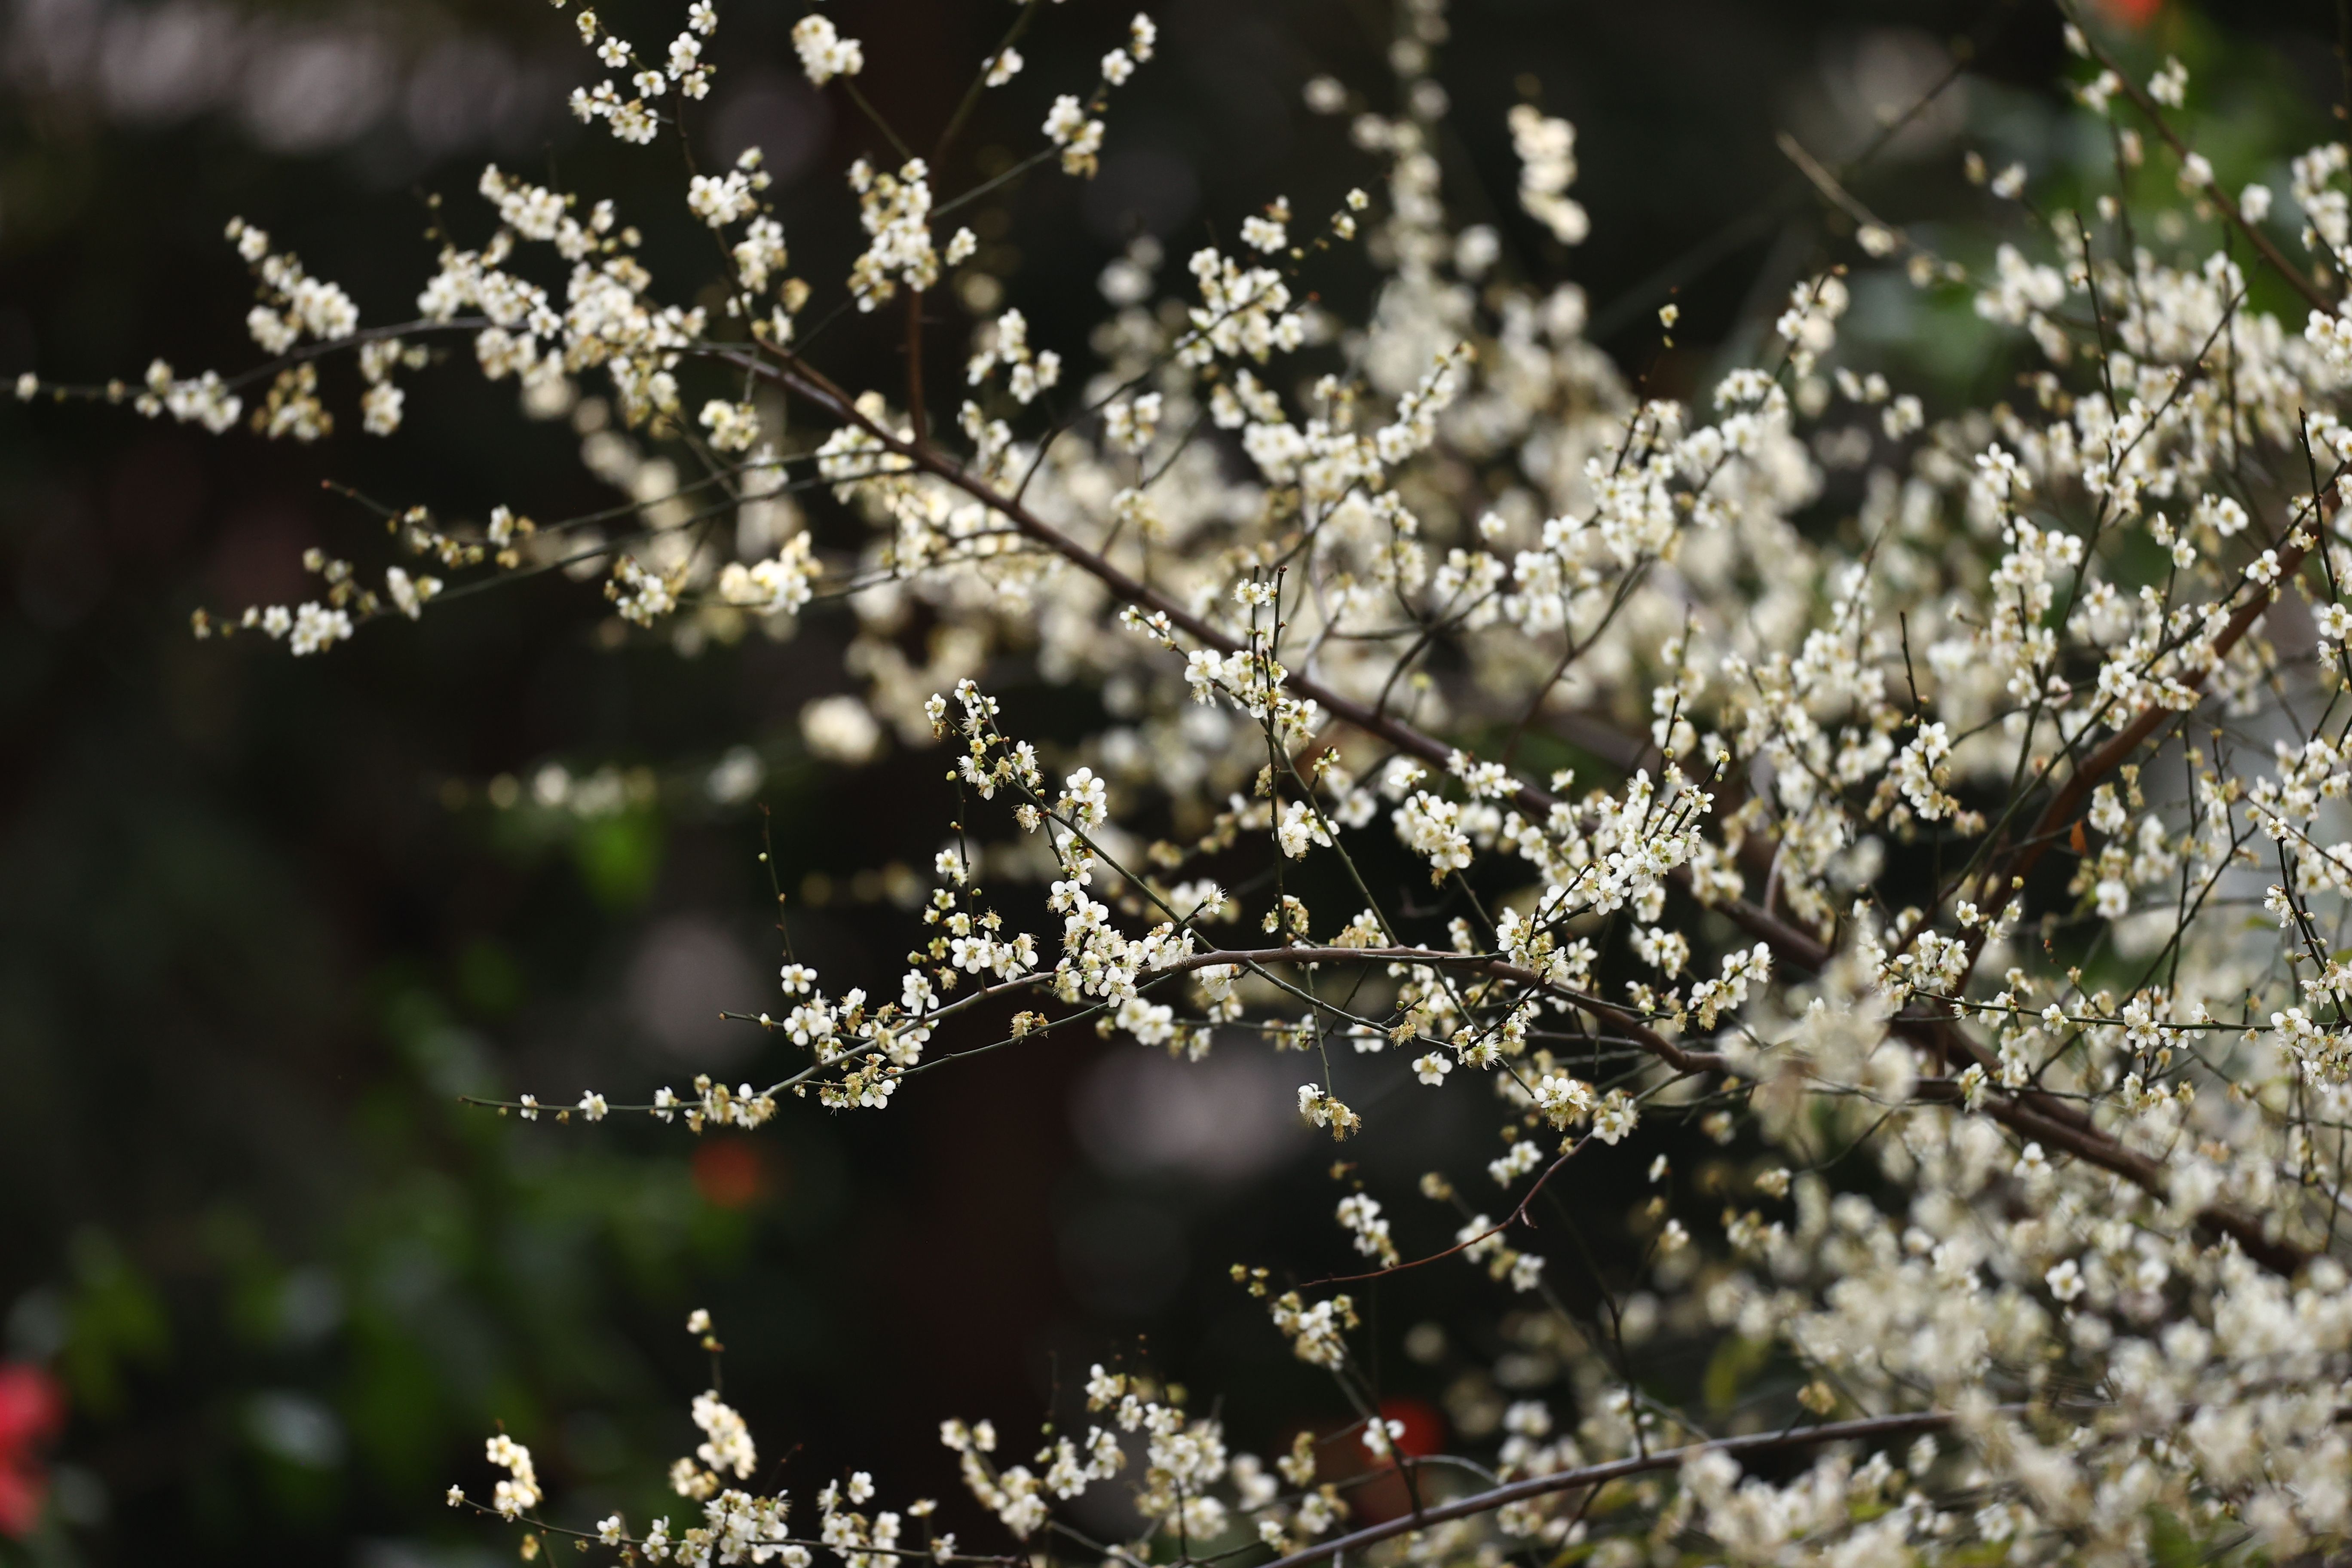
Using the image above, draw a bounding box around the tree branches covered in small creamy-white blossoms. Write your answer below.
[19,0,2352,1568]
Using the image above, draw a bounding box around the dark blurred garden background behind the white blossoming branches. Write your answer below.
[0,0,2340,1568]
